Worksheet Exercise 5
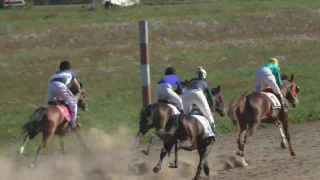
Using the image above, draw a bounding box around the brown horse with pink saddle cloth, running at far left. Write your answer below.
[20,83,90,167]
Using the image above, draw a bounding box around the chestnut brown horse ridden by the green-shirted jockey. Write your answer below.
[228,74,296,166]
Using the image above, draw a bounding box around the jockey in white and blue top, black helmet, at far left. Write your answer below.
[46,61,81,129]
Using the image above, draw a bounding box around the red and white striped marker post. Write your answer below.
[139,21,151,107]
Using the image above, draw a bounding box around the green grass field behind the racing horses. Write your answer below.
[0,0,320,155]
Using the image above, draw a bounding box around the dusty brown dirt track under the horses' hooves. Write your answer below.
[0,122,320,180]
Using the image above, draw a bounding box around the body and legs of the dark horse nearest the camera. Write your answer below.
[153,114,214,180]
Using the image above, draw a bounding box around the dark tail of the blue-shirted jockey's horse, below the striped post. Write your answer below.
[139,104,157,135]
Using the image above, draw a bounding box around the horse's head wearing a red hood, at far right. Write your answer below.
[281,74,300,108]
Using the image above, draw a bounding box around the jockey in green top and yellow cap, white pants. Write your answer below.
[254,58,290,112]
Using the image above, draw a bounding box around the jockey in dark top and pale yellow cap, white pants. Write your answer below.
[182,66,215,140]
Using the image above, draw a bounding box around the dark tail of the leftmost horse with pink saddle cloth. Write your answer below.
[23,107,47,140]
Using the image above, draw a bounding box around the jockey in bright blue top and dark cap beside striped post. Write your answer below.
[156,67,184,113]
